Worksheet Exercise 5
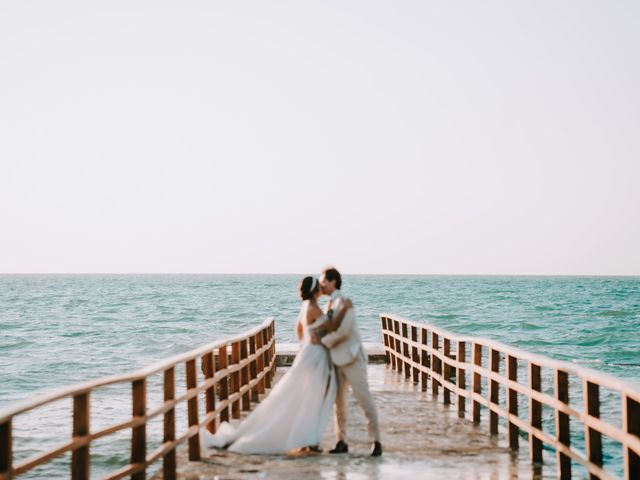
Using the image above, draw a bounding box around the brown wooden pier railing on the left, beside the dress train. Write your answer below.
[0,318,276,480]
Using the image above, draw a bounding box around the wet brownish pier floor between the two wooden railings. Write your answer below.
[154,365,555,480]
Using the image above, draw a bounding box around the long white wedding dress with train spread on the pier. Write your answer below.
[201,300,337,454]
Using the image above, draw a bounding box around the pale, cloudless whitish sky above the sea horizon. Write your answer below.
[0,0,640,275]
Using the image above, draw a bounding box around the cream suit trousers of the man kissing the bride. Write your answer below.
[334,354,380,442]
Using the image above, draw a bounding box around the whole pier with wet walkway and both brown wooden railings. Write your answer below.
[0,314,640,480]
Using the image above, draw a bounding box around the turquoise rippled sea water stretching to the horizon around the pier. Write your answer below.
[0,275,640,478]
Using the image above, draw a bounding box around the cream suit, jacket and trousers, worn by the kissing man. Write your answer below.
[322,290,380,442]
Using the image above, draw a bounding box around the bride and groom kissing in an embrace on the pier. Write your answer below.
[202,268,382,456]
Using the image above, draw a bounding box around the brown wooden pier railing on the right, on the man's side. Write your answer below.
[381,314,640,480]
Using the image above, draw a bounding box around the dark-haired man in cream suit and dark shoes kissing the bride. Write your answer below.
[311,268,382,457]
